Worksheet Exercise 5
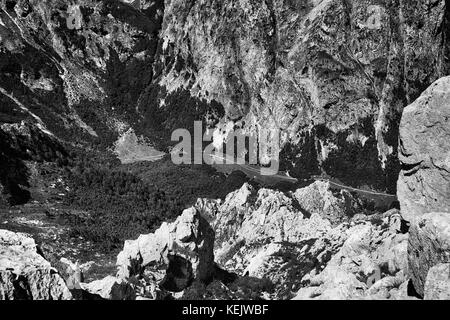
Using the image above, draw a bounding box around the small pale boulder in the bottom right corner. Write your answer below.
[424,263,450,300]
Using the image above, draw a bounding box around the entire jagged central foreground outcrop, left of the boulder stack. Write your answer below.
[83,182,409,299]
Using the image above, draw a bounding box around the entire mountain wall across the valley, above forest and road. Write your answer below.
[0,0,450,193]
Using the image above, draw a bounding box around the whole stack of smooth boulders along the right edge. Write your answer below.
[398,77,450,299]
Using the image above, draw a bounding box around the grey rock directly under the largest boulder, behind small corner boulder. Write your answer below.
[408,213,450,297]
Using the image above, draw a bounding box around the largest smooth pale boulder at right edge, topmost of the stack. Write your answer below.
[398,77,450,220]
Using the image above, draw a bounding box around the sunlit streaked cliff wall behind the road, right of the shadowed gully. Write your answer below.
[156,0,448,191]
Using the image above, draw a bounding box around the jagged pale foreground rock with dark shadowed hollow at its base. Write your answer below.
[117,208,214,292]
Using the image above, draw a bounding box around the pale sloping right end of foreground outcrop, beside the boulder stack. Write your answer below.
[295,212,408,300]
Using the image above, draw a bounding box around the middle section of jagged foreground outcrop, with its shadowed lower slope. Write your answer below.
[200,182,370,299]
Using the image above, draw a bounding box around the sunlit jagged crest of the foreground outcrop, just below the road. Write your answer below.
[212,182,359,261]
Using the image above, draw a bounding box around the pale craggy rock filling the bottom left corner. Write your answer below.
[0,230,72,300]
